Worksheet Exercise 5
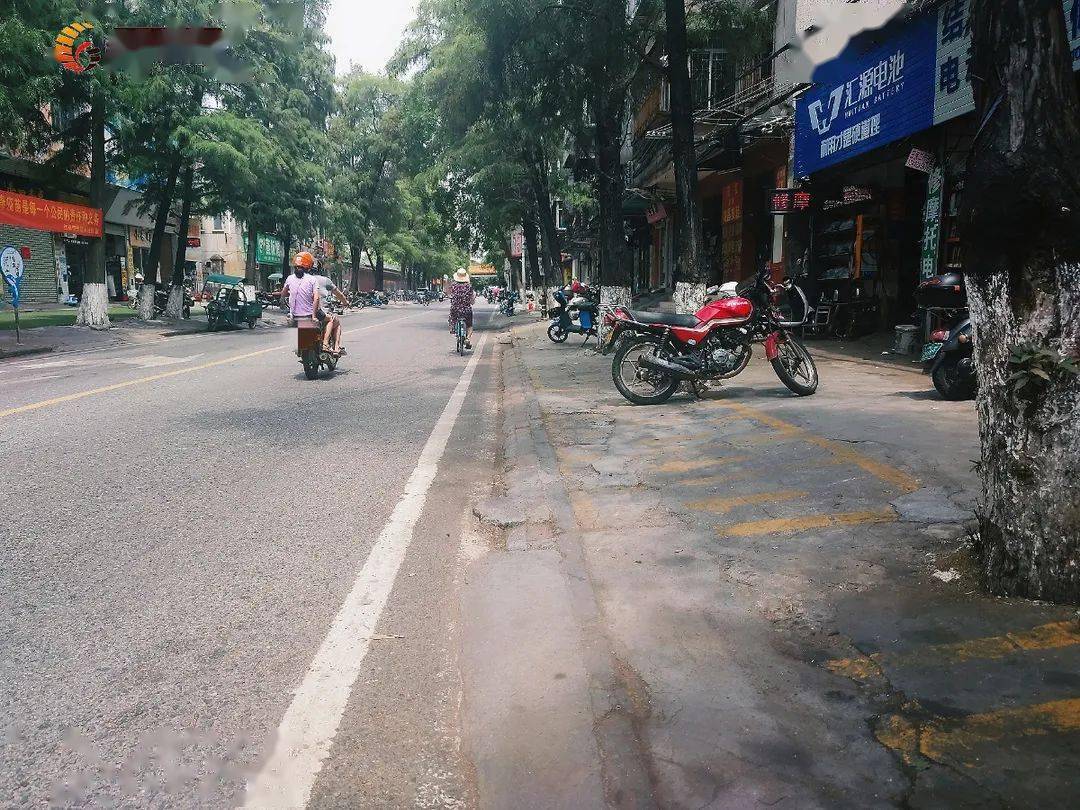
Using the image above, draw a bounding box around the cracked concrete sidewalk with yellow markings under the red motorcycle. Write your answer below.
[507,324,1080,808]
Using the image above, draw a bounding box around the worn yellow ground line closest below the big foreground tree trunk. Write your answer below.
[825,621,1080,680]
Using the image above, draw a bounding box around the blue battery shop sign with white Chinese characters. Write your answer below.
[795,0,1080,177]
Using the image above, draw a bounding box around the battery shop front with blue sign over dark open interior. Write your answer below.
[785,0,1080,336]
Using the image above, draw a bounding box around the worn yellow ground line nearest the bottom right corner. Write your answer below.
[875,698,1080,765]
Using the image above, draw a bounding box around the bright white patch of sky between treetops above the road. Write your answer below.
[326,0,416,76]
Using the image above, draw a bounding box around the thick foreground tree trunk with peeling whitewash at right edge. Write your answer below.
[961,0,1080,603]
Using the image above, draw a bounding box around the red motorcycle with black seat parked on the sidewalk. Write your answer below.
[605,268,818,405]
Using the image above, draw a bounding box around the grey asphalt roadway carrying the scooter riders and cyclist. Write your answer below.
[0,305,496,807]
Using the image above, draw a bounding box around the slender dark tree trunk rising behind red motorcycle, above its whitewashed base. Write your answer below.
[664,0,708,285]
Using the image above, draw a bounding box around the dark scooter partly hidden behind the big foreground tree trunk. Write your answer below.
[916,273,978,401]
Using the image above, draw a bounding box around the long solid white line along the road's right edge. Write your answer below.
[244,335,487,810]
